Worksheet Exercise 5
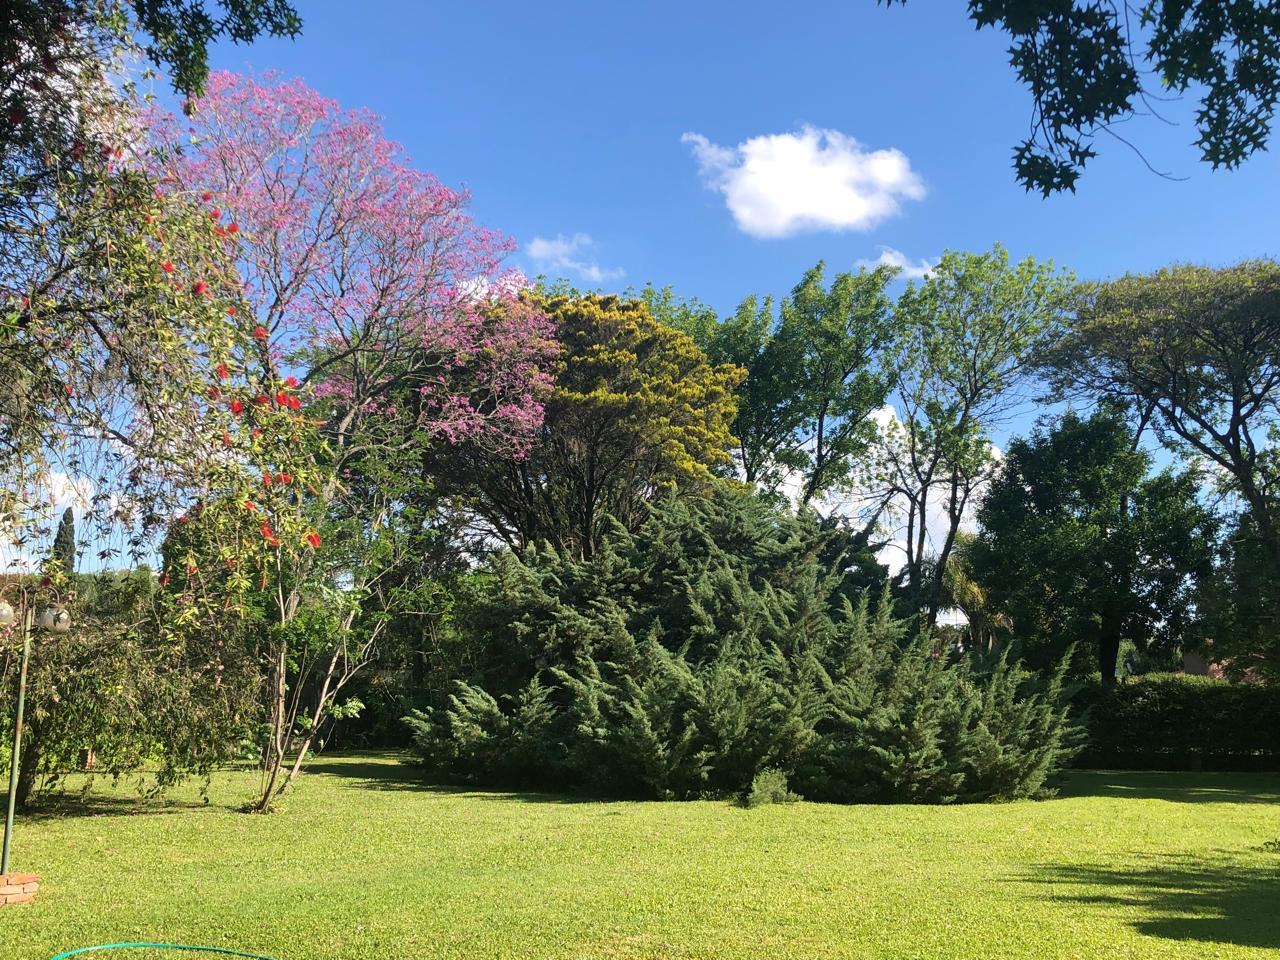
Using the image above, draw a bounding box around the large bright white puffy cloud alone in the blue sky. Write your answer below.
[681,125,924,237]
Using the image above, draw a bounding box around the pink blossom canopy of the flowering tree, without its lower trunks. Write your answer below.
[154,72,556,456]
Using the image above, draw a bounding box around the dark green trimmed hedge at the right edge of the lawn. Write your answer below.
[1071,673,1280,771]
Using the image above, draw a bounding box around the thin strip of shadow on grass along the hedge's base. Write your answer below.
[1057,771,1280,804]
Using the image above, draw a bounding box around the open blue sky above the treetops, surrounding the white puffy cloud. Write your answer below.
[212,0,1280,311]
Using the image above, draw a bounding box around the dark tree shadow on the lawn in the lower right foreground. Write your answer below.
[1029,854,1280,948]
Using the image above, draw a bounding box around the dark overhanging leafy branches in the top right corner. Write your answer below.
[881,0,1280,196]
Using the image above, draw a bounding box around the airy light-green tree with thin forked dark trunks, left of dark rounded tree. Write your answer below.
[879,244,1071,625]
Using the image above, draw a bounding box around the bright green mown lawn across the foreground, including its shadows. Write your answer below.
[0,755,1280,960]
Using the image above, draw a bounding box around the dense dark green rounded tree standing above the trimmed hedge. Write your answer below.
[970,411,1216,684]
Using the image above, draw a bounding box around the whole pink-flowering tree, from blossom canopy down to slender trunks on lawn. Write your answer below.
[154,73,556,810]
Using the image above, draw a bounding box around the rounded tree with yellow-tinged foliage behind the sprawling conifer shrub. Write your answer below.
[430,294,742,556]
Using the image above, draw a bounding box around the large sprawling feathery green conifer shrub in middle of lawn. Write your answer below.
[406,488,1075,803]
